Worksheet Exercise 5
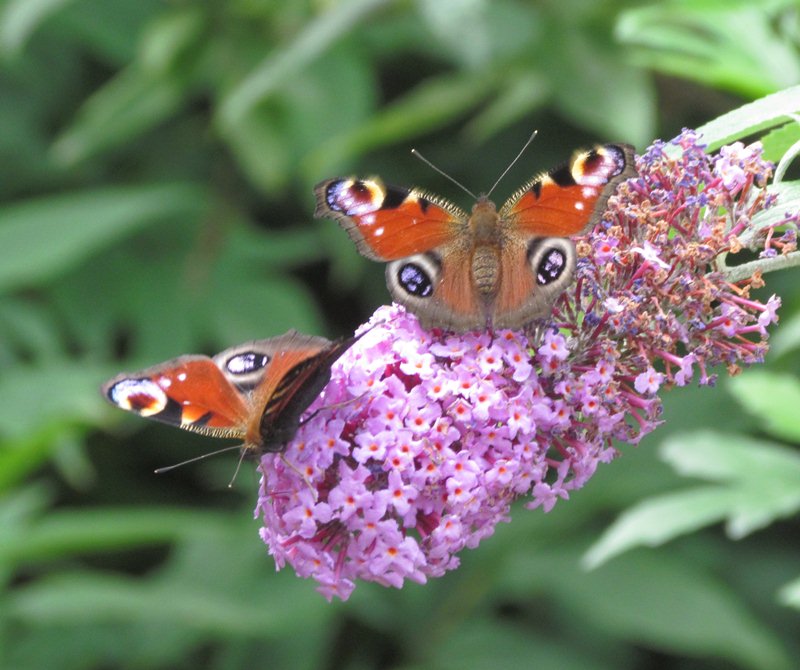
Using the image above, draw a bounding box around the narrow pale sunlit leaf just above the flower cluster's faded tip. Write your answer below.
[697,86,800,151]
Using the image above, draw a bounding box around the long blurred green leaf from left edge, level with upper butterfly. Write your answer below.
[0,184,207,291]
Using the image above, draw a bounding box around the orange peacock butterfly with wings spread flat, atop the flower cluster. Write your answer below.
[315,144,636,331]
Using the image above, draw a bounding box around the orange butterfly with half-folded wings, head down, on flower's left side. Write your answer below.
[102,330,360,454]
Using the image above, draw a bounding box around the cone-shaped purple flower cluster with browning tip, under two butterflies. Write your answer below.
[256,131,796,599]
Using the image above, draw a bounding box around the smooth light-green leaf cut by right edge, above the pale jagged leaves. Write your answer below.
[729,370,800,443]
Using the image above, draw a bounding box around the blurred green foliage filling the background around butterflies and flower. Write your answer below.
[0,0,800,670]
